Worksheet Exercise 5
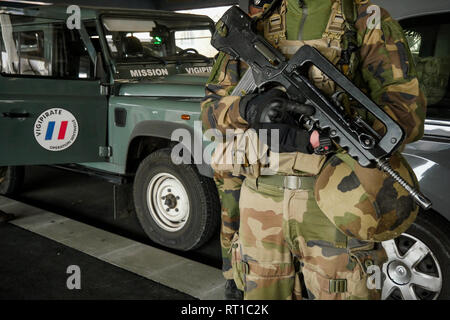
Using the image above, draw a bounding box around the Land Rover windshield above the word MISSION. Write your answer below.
[103,17,217,63]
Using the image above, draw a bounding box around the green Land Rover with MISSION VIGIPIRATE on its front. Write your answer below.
[0,6,220,250]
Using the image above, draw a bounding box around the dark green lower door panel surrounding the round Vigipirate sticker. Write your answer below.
[0,77,108,165]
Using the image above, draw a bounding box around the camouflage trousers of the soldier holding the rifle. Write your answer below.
[232,176,386,299]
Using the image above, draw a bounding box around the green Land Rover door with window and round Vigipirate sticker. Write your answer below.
[0,13,108,166]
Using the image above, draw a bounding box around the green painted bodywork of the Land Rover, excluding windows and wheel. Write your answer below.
[0,6,213,174]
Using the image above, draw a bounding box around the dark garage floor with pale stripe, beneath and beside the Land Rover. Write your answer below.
[0,167,223,300]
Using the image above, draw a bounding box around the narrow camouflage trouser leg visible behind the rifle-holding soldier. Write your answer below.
[214,172,244,280]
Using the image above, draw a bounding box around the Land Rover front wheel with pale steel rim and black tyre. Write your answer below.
[133,149,220,251]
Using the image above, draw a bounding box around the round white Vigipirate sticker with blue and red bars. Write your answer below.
[34,108,79,151]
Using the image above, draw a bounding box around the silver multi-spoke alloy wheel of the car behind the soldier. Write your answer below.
[382,212,450,300]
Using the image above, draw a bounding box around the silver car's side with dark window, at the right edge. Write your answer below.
[401,13,450,219]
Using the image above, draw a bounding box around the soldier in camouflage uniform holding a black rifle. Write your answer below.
[202,0,426,299]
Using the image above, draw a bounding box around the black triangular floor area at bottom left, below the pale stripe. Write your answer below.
[0,224,193,300]
